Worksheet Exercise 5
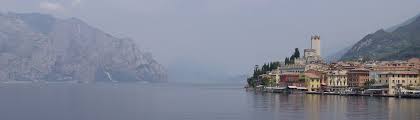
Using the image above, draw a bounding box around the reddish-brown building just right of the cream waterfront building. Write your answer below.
[347,68,369,88]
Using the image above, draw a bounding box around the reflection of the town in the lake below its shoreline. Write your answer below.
[248,92,420,120]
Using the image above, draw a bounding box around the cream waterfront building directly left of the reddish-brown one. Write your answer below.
[327,70,348,92]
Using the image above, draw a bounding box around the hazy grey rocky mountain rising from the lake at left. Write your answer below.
[0,13,166,82]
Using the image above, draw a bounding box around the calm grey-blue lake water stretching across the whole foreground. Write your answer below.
[0,84,420,120]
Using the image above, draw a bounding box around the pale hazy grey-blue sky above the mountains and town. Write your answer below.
[0,0,420,78]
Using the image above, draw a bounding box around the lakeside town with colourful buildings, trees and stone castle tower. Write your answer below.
[246,35,420,98]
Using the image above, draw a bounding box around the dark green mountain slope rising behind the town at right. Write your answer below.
[341,13,420,60]
